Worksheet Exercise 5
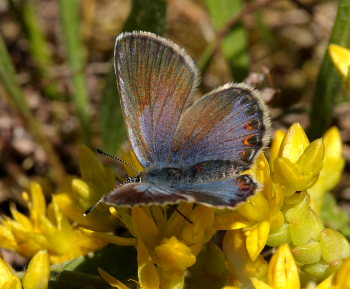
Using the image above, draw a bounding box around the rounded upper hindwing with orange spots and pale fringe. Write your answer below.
[168,84,270,167]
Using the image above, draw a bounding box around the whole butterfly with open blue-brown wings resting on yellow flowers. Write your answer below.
[95,32,270,208]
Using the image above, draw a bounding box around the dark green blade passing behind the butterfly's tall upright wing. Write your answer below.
[100,0,167,154]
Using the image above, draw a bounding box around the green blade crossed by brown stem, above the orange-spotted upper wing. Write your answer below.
[202,0,250,82]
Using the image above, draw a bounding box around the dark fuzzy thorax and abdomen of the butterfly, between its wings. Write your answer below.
[141,160,246,187]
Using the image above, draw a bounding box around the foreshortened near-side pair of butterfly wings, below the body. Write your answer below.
[102,175,257,207]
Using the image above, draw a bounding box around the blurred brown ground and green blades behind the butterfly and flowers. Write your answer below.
[0,0,350,216]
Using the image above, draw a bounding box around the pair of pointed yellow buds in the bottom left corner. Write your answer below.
[0,250,50,289]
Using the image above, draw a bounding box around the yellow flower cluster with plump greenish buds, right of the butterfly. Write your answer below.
[217,124,350,286]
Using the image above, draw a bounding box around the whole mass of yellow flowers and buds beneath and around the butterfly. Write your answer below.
[0,123,350,289]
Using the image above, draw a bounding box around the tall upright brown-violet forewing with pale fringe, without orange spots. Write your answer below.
[115,32,197,167]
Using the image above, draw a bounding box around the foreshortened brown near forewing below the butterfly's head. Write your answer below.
[102,182,195,207]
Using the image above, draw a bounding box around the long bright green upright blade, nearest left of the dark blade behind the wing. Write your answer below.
[58,0,91,144]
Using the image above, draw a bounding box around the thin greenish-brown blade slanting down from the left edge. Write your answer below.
[0,35,65,181]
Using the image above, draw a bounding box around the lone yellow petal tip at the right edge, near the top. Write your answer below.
[329,44,350,81]
